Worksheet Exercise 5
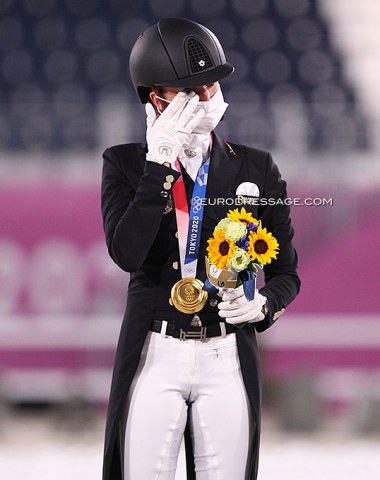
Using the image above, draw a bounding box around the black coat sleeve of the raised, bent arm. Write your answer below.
[101,147,180,272]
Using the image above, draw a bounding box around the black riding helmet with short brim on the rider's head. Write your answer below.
[129,18,234,103]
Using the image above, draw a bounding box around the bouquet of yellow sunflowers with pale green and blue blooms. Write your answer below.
[205,207,279,300]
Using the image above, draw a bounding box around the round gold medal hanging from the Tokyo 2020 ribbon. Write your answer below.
[171,277,208,313]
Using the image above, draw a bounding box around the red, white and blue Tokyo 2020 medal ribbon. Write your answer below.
[173,144,211,278]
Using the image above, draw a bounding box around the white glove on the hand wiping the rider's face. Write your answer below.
[146,92,205,165]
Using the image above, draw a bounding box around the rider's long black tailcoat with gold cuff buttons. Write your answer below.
[102,135,300,480]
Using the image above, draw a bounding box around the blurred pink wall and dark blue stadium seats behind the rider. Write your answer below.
[0,0,380,476]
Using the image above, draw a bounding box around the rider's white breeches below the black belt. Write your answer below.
[124,332,250,480]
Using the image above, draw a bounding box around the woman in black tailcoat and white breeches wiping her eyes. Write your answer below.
[102,19,300,480]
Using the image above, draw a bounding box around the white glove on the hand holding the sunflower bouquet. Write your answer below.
[218,285,267,325]
